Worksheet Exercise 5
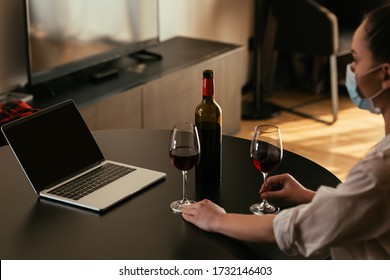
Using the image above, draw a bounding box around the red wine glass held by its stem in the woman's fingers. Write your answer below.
[250,125,283,215]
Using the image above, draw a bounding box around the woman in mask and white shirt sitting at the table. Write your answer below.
[182,5,390,259]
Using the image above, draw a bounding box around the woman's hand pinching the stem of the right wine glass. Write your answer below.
[259,174,315,205]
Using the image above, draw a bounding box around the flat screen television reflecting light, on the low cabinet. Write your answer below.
[26,0,159,85]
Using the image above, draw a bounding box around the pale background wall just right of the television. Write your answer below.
[159,0,254,82]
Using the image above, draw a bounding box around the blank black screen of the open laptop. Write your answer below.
[3,101,104,193]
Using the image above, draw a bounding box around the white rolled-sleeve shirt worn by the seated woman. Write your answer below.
[273,135,390,259]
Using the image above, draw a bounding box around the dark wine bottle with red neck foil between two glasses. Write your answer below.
[195,70,222,186]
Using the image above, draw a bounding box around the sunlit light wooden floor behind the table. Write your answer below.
[235,90,384,180]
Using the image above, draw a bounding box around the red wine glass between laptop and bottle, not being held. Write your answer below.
[169,123,200,213]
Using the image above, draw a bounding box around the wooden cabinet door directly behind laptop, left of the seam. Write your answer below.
[80,87,142,130]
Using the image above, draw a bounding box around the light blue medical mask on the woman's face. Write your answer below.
[345,64,383,114]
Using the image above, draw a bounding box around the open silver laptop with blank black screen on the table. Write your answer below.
[1,100,166,211]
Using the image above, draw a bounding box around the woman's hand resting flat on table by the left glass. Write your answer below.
[181,199,226,231]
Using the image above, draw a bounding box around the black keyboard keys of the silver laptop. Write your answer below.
[49,163,135,200]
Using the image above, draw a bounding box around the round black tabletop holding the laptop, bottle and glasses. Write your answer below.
[0,129,340,260]
